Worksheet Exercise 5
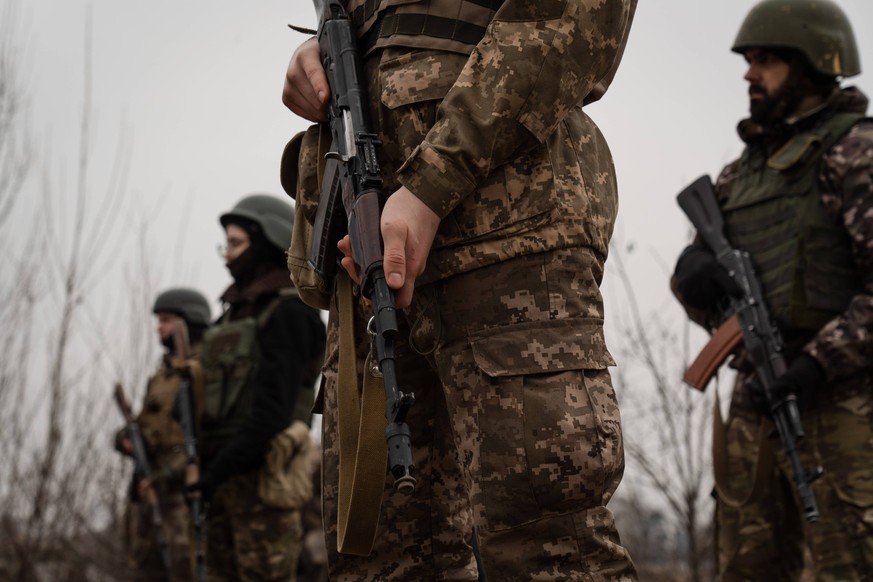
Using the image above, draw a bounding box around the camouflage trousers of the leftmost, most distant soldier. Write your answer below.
[125,491,194,582]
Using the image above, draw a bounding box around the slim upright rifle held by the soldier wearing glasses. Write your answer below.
[173,317,206,582]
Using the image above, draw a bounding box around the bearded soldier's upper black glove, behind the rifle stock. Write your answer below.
[674,243,742,309]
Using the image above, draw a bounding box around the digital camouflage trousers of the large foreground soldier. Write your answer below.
[323,249,635,582]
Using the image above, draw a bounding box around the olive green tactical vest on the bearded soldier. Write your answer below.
[723,113,863,330]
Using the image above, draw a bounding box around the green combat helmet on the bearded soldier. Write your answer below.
[731,0,861,77]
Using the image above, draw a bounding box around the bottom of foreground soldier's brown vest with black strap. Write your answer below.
[347,0,503,55]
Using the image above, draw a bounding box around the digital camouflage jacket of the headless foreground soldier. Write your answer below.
[297,0,620,283]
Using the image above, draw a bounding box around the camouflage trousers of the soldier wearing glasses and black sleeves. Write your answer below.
[206,471,303,582]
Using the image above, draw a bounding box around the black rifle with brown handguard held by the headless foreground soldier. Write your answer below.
[309,0,415,493]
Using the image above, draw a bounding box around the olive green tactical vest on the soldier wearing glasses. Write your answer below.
[201,287,315,443]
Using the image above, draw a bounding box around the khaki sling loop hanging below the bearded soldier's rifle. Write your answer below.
[712,390,773,509]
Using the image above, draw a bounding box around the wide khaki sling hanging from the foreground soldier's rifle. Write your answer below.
[336,269,388,556]
